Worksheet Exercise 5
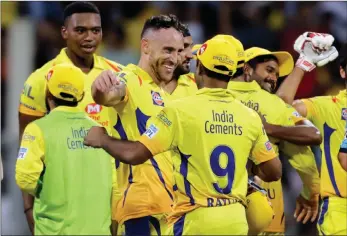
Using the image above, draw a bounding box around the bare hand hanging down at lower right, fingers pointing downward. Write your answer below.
[294,194,319,224]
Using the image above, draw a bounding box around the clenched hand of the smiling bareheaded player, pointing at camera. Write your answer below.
[93,70,124,93]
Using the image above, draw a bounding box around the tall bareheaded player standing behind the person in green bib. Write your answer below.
[19,2,123,233]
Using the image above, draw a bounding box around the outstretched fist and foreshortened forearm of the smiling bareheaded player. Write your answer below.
[92,70,128,107]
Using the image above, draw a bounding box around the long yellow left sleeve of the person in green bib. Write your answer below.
[16,123,44,195]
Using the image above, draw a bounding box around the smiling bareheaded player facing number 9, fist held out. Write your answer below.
[92,15,196,235]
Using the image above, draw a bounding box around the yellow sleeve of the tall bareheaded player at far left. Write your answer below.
[19,72,47,116]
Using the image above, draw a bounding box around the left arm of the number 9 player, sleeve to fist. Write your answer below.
[84,107,177,165]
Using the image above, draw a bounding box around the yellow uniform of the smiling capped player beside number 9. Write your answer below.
[228,81,319,233]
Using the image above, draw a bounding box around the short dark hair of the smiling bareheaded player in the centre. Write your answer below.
[141,14,182,39]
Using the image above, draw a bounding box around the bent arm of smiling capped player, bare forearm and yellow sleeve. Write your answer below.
[263,106,322,146]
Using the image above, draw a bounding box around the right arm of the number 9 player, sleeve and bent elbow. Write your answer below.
[251,113,282,182]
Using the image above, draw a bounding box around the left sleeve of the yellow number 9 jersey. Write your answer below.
[138,107,178,156]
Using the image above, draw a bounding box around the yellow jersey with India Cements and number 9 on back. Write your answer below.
[139,88,276,223]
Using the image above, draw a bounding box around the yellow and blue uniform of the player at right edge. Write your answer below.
[302,90,347,235]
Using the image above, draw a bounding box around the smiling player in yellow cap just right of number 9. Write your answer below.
[229,47,321,234]
